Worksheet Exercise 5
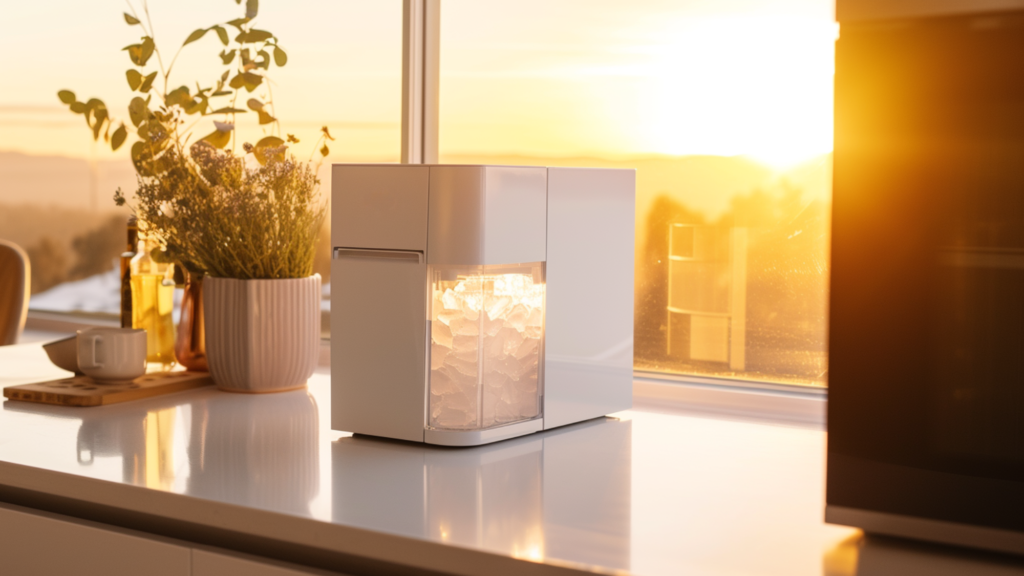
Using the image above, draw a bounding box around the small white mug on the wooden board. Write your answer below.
[78,328,145,380]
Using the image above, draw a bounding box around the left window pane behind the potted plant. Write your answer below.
[0,0,401,330]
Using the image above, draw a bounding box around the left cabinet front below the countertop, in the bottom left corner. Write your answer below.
[0,504,191,576]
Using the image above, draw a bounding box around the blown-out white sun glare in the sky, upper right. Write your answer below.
[639,16,838,169]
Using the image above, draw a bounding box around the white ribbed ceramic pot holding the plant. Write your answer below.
[203,274,321,394]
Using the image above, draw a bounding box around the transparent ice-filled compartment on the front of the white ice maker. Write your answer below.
[428,263,545,430]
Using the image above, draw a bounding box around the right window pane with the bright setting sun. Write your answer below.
[440,0,838,385]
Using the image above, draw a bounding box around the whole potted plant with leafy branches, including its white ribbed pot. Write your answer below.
[57,0,334,392]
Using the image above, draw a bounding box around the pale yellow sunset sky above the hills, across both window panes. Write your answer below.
[0,0,838,168]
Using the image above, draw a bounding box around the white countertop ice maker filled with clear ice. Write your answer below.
[331,164,635,446]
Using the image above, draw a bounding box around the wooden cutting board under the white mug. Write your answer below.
[3,371,213,407]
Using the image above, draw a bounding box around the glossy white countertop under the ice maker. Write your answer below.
[0,345,1024,576]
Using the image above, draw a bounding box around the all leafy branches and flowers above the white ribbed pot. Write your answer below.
[57,0,334,278]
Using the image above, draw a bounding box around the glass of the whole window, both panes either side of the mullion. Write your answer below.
[8,0,838,386]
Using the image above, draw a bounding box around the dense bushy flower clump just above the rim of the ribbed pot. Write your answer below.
[116,141,327,280]
